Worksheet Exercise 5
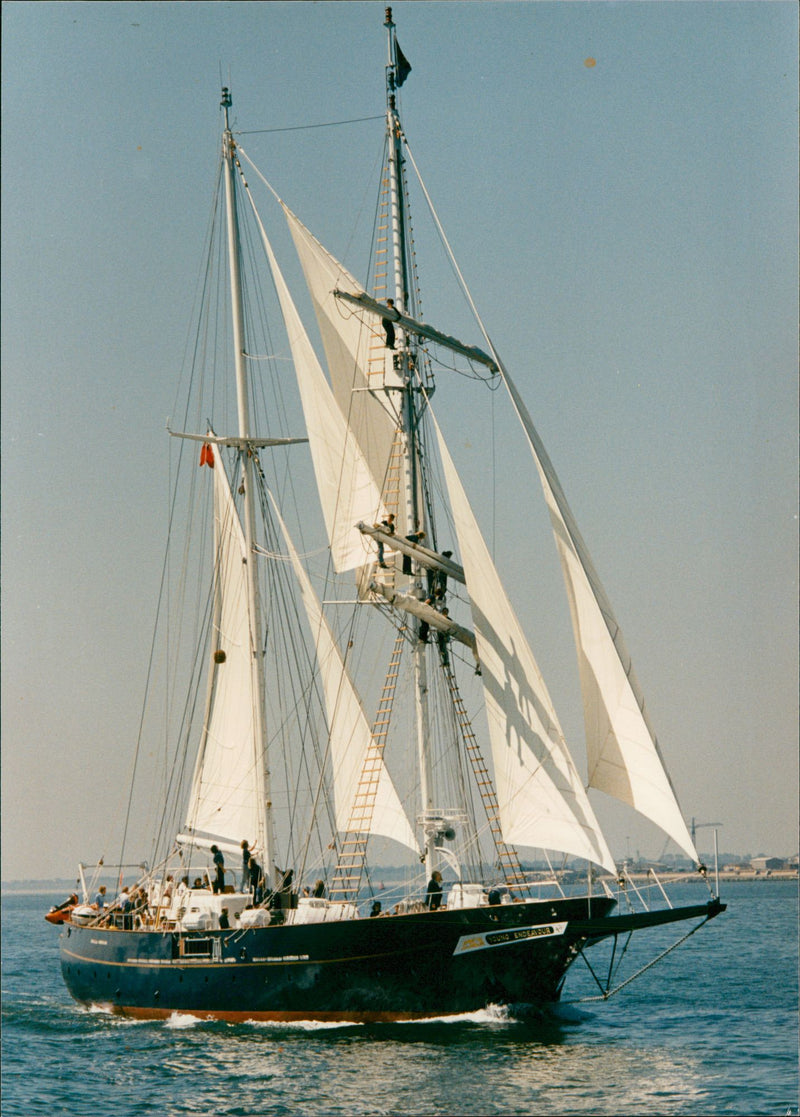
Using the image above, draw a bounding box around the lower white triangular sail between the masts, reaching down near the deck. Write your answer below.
[273,497,419,852]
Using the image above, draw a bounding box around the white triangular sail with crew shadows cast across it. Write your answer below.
[437,426,615,872]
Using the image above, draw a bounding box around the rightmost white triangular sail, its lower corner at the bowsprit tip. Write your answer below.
[498,361,697,861]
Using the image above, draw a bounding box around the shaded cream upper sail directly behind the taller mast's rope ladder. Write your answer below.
[282,203,411,535]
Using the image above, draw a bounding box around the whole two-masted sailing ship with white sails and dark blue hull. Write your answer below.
[59,9,724,1021]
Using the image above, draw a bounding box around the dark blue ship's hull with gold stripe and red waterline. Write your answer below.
[60,898,613,1020]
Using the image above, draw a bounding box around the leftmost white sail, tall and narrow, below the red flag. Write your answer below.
[184,452,264,847]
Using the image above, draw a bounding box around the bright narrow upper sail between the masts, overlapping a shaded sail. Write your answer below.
[256,198,387,573]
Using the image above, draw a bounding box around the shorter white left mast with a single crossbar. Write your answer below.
[220,88,275,873]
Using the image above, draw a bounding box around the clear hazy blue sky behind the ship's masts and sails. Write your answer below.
[2,0,798,879]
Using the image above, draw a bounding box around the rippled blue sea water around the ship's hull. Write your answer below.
[1,881,798,1117]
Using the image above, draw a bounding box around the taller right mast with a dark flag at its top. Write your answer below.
[384,8,437,876]
